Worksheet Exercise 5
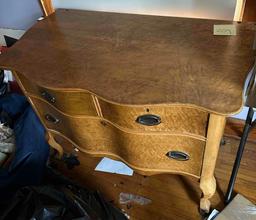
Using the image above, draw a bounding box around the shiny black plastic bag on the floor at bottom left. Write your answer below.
[0,168,127,220]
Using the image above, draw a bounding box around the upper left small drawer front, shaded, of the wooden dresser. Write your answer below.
[15,74,97,116]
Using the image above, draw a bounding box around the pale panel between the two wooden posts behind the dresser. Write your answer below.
[52,0,236,20]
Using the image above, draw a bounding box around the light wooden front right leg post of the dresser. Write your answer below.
[200,114,226,213]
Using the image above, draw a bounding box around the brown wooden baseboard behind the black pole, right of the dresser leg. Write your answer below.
[224,118,256,142]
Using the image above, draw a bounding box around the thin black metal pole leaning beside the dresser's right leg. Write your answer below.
[225,107,256,204]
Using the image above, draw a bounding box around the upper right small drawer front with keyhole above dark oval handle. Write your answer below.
[99,100,209,137]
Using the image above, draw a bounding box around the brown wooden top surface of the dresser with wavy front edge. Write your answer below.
[0,10,256,115]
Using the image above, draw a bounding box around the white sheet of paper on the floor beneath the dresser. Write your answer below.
[95,157,133,176]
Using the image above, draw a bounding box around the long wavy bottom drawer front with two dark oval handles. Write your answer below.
[32,98,205,177]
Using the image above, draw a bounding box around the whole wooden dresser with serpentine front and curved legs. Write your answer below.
[0,10,256,212]
